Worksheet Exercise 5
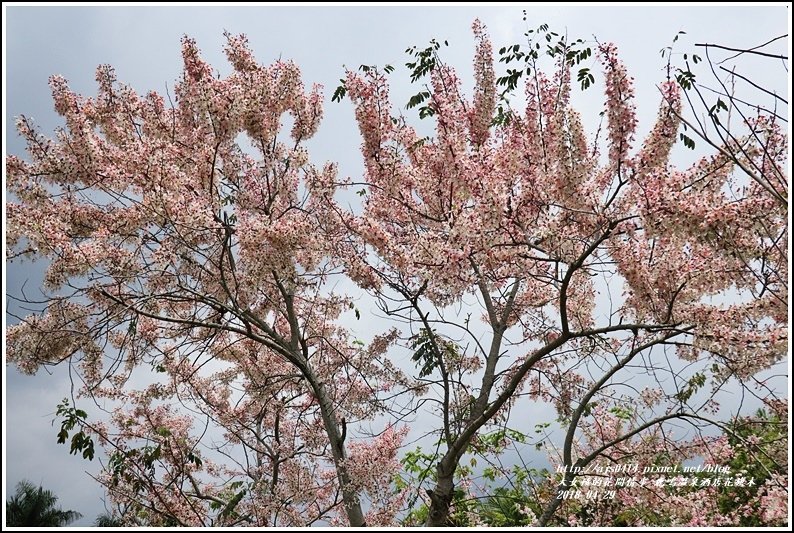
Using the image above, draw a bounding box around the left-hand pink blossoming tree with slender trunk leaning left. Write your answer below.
[7,36,412,525]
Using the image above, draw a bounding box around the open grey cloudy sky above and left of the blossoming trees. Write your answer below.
[3,4,790,525]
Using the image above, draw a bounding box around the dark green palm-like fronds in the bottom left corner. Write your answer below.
[6,481,82,527]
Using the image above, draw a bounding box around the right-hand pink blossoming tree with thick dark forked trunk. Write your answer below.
[341,19,788,525]
